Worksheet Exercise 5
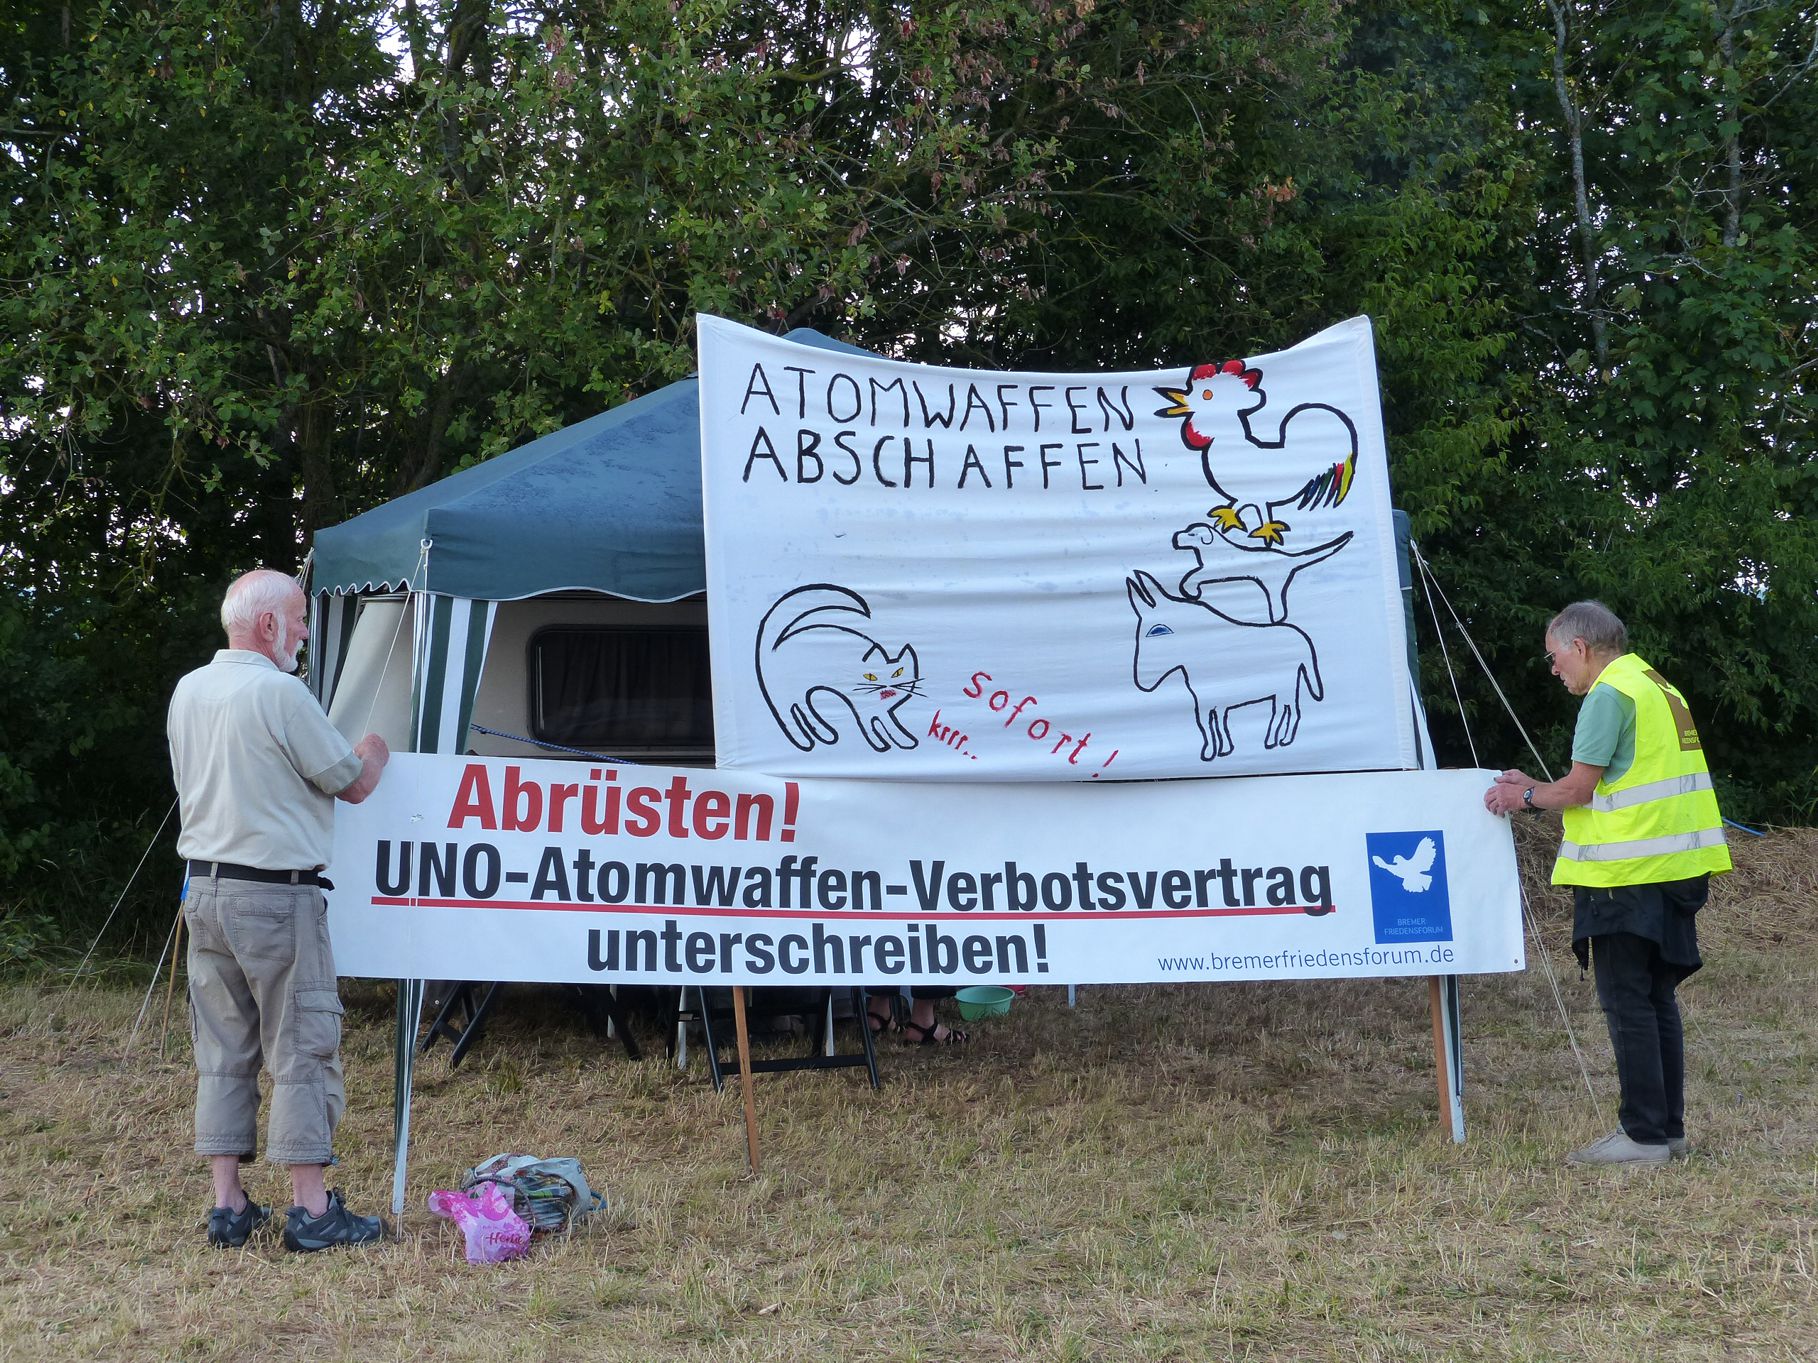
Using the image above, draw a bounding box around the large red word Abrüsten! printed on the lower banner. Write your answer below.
[449,761,802,843]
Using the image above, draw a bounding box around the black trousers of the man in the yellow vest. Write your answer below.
[1591,932,1685,1145]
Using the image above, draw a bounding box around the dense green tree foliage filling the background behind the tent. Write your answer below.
[0,0,1818,952]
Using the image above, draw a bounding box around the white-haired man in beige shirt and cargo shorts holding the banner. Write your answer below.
[167,569,391,1252]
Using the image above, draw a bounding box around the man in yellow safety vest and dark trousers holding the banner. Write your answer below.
[1483,602,1729,1165]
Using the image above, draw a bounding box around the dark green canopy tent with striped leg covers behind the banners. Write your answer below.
[309,329,867,1212]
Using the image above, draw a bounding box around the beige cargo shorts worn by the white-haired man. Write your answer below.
[184,876,347,1165]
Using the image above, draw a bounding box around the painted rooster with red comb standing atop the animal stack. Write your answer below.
[1156,360,1358,545]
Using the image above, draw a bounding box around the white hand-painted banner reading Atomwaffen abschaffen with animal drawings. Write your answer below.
[698,316,1418,781]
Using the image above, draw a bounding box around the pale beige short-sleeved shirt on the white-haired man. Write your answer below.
[167,649,362,871]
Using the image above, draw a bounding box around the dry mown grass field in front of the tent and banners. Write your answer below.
[0,820,1818,1363]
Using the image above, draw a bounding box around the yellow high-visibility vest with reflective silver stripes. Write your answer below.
[1553,652,1729,885]
